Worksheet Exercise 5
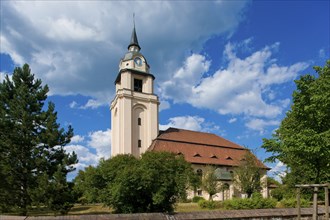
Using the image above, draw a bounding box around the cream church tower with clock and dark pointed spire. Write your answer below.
[110,25,159,157]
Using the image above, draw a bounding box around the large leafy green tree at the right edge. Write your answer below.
[262,60,330,185]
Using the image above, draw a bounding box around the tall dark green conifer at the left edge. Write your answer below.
[0,64,77,215]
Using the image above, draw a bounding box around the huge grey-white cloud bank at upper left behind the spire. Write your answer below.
[0,1,248,108]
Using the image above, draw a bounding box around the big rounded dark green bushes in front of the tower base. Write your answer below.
[74,152,195,213]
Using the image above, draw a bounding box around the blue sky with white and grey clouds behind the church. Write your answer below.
[0,0,330,180]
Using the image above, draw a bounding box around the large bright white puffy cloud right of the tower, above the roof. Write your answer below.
[161,41,309,130]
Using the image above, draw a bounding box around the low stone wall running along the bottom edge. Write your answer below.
[0,207,325,220]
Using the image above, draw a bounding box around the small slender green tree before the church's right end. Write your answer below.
[234,152,261,198]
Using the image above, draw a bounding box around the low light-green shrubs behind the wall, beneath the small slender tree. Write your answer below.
[223,193,276,210]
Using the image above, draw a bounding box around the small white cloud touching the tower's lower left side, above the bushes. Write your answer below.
[88,129,111,159]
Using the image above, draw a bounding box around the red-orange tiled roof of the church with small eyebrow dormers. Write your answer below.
[149,128,268,169]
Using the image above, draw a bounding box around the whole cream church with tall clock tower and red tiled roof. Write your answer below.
[110,27,269,200]
